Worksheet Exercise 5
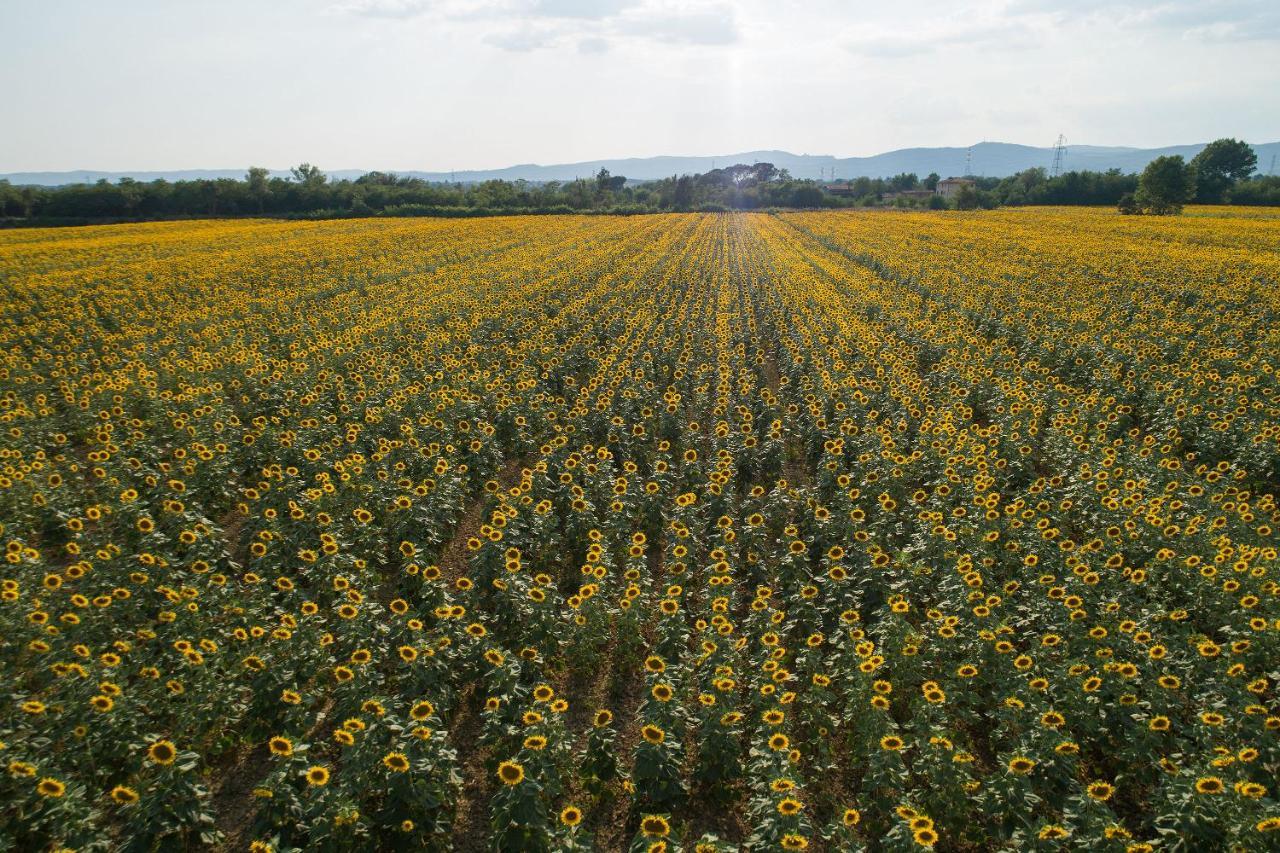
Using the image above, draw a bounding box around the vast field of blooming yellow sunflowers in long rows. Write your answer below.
[0,207,1280,853]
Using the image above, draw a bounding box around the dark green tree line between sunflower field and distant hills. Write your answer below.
[0,140,1280,224]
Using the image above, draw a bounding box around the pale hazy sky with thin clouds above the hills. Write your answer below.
[0,0,1280,172]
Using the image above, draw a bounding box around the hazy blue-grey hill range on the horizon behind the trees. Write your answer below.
[0,142,1280,186]
